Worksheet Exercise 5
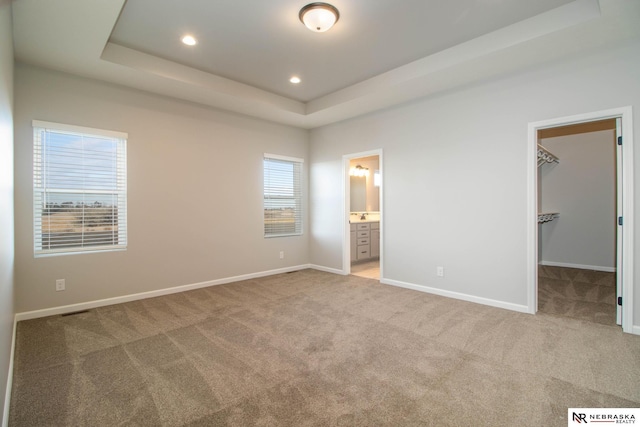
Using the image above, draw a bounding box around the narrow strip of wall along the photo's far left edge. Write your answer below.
[0,0,15,420]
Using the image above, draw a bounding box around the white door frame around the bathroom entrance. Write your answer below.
[342,148,384,281]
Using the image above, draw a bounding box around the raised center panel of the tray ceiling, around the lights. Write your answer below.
[110,0,572,102]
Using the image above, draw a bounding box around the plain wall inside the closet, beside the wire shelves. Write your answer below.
[539,130,616,270]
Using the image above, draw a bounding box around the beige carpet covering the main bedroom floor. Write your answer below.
[10,270,640,427]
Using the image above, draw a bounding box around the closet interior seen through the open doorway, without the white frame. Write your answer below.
[537,119,619,326]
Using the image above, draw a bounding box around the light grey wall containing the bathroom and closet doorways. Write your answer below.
[310,39,640,327]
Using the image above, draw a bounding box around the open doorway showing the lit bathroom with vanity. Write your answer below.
[343,150,383,280]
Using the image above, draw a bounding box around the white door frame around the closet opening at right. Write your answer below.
[527,106,634,333]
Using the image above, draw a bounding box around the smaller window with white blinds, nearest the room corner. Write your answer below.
[264,154,303,237]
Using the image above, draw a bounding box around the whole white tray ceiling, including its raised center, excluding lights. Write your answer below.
[12,0,640,128]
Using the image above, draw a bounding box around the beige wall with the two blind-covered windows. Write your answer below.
[15,64,309,312]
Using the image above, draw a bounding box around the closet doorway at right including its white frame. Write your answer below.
[529,109,633,332]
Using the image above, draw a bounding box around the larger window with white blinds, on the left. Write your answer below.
[33,120,127,255]
